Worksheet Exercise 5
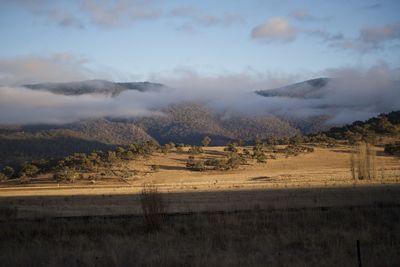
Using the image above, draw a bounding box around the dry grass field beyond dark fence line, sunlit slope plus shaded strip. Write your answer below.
[0,146,400,218]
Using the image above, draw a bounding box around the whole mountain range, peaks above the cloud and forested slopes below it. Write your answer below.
[6,78,390,167]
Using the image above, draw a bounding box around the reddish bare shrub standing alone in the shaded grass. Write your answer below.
[140,184,167,232]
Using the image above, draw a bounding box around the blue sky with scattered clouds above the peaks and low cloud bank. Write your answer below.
[0,0,400,85]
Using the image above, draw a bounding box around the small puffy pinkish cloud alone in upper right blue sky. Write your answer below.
[251,17,297,42]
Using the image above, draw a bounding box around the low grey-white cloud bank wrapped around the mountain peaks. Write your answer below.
[0,54,400,124]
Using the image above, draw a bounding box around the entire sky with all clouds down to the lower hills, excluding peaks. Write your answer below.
[0,0,400,124]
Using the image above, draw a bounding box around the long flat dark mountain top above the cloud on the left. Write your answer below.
[24,80,164,96]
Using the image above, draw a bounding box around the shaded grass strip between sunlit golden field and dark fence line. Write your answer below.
[0,185,400,221]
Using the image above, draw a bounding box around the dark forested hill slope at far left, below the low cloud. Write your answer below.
[0,119,152,167]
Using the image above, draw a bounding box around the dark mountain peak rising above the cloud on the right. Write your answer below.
[256,78,332,99]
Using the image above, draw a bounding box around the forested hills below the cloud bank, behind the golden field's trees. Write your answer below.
[0,102,300,165]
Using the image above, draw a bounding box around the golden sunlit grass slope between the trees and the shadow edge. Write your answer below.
[0,146,400,196]
